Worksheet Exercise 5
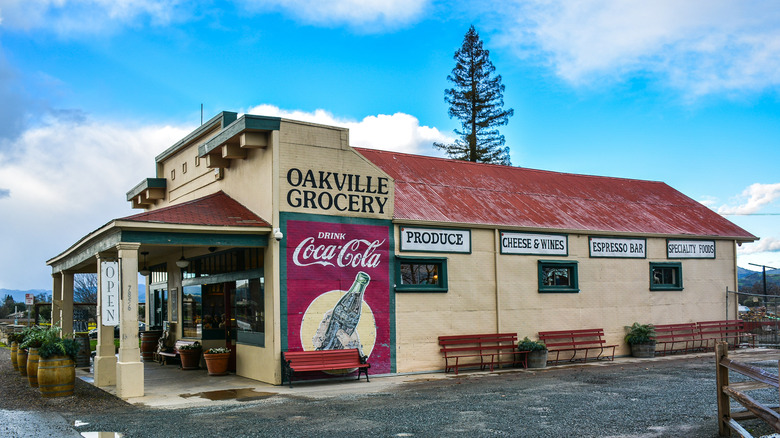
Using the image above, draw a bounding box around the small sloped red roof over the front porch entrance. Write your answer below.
[119,191,271,227]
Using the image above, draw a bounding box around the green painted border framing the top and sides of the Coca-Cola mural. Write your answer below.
[279,212,397,373]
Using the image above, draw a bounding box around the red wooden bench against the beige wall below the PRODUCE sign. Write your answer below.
[439,333,528,374]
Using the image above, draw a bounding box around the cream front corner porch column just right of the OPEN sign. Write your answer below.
[116,243,144,398]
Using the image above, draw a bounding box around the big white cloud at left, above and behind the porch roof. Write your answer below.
[0,114,190,289]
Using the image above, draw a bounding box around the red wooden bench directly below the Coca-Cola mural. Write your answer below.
[282,348,371,388]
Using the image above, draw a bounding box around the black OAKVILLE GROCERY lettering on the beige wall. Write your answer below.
[287,167,390,214]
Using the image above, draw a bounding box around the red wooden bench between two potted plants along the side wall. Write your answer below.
[539,328,617,365]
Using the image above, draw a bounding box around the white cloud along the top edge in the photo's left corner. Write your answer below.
[0,0,186,35]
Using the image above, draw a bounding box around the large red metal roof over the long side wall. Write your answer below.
[355,148,757,240]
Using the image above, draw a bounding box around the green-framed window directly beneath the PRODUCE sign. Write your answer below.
[395,257,447,292]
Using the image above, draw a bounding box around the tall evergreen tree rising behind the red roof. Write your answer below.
[433,25,514,166]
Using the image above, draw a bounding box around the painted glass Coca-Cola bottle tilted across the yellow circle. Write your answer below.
[313,271,371,354]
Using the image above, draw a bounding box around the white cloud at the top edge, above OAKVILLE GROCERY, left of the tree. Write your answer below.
[243,0,430,33]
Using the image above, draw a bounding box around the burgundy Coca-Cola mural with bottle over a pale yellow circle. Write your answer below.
[285,220,391,373]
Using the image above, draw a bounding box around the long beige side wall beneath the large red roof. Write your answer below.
[395,225,736,372]
